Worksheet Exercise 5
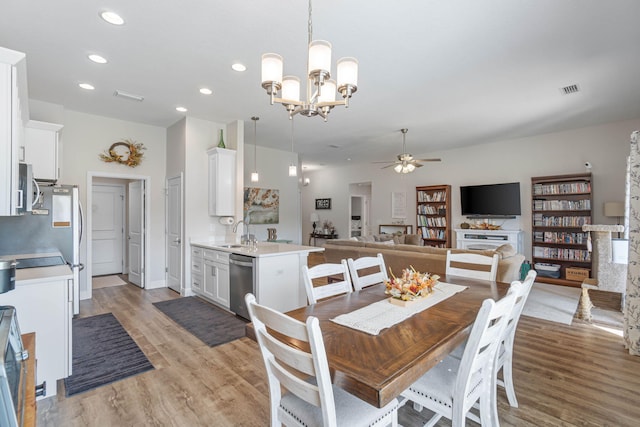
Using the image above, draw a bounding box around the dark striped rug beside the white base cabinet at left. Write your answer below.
[64,313,154,397]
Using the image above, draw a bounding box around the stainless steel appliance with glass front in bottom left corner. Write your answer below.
[0,306,29,427]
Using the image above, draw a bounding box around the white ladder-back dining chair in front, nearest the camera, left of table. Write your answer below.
[245,294,398,427]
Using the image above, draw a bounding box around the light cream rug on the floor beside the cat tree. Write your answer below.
[522,282,581,325]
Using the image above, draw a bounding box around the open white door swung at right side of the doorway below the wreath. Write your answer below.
[128,180,145,288]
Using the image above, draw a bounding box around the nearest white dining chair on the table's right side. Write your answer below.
[401,290,515,427]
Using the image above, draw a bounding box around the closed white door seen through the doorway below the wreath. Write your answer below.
[91,184,124,276]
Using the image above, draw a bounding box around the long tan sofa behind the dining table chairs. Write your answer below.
[323,235,525,283]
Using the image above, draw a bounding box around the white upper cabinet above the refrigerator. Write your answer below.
[24,120,62,182]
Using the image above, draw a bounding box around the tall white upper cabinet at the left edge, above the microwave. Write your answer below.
[0,47,29,216]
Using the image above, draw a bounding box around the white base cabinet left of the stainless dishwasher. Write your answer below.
[191,246,230,309]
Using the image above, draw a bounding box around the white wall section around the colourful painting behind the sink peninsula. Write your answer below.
[244,144,308,245]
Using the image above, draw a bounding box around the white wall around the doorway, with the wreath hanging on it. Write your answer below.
[58,110,166,298]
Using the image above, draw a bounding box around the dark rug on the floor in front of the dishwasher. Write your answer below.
[153,297,247,347]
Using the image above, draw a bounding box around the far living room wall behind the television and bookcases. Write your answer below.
[302,119,640,259]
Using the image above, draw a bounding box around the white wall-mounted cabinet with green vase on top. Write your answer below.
[207,147,236,216]
